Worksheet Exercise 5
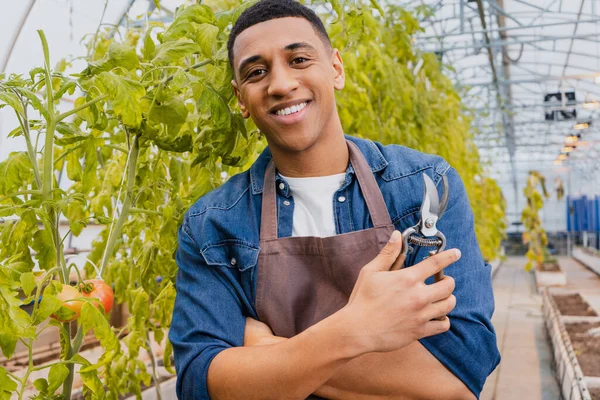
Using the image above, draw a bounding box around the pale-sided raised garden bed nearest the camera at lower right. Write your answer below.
[541,288,600,400]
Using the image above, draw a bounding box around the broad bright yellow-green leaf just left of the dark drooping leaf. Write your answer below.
[98,72,146,127]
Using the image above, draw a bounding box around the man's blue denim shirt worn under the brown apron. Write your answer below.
[169,136,500,399]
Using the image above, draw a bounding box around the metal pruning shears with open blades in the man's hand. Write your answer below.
[401,174,449,282]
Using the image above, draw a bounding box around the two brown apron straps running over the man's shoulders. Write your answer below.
[260,140,392,240]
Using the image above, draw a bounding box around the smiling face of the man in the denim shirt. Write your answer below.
[232,17,344,152]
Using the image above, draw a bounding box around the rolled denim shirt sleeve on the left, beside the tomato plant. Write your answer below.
[169,220,245,400]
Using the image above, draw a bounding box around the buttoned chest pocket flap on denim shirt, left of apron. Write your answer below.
[202,242,260,271]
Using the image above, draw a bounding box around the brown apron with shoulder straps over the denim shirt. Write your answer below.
[256,141,394,338]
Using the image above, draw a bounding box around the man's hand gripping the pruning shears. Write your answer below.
[341,231,460,353]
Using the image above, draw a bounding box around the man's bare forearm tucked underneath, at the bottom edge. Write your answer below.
[315,342,475,400]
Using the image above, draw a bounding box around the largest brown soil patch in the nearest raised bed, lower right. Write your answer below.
[565,322,600,378]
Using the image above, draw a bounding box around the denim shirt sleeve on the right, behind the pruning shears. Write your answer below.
[413,168,500,397]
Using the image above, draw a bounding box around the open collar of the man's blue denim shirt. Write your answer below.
[250,135,388,194]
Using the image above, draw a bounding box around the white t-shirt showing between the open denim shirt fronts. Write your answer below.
[280,173,346,237]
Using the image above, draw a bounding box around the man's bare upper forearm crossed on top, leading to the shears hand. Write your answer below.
[208,314,362,400]
